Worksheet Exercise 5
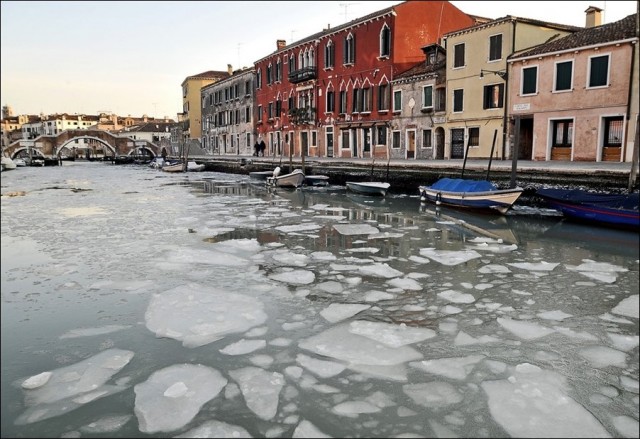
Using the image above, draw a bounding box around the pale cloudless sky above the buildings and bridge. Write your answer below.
[0,0,638,119]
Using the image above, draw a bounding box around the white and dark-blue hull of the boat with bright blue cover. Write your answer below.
[419,186,523,214]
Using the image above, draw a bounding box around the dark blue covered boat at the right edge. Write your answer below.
[535,188,640,229]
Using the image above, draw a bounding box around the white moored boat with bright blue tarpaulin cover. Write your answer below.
[418,178,524,214]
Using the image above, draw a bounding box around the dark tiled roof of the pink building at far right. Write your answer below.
[509,14,637,60]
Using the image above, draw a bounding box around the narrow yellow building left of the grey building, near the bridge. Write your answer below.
[178,68,231,141]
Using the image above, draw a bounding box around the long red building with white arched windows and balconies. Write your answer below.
[254,1,475,162]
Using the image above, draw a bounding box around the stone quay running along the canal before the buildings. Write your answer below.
[184,155,639,193]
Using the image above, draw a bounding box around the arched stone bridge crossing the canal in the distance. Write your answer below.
[4,130,164,159]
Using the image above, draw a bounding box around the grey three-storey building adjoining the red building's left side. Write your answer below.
[201,67,257,155]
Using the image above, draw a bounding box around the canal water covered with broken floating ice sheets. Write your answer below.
[1,162,639,438]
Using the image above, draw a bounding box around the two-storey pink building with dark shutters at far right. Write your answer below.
[509,7,638,162]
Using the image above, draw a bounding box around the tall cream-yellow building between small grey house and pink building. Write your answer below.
[443,16,582,159]
